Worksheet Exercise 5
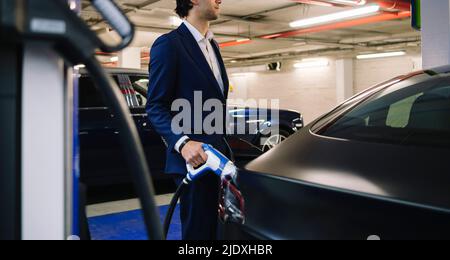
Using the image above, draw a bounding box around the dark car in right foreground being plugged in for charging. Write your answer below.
[221,66,450,240]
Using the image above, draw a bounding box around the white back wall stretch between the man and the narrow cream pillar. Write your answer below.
[230,62,336,122]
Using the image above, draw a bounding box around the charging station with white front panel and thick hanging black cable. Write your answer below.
[0,0,163,240]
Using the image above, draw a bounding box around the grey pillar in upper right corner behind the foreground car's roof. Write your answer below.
[421,0,450,69]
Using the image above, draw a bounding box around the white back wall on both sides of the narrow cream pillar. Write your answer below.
[230,55,421,123]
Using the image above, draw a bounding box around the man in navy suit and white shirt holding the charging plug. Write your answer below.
[147,0,231,240]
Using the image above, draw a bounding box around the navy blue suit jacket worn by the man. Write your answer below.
[146,24,230,174]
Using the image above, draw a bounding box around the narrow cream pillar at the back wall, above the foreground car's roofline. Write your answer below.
[336,59,353,104]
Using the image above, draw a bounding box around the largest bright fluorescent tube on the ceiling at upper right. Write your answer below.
[290,5,380,28]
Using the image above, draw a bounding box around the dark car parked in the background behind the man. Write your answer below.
[79,69,303,186]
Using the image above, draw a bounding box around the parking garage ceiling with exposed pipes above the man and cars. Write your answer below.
[82,0,420,66]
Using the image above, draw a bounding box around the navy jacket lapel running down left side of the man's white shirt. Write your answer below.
[178,24,225,101]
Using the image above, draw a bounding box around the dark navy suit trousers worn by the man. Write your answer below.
[175,173,220,241]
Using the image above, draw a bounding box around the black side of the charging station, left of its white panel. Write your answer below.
[0,37,22,239]
